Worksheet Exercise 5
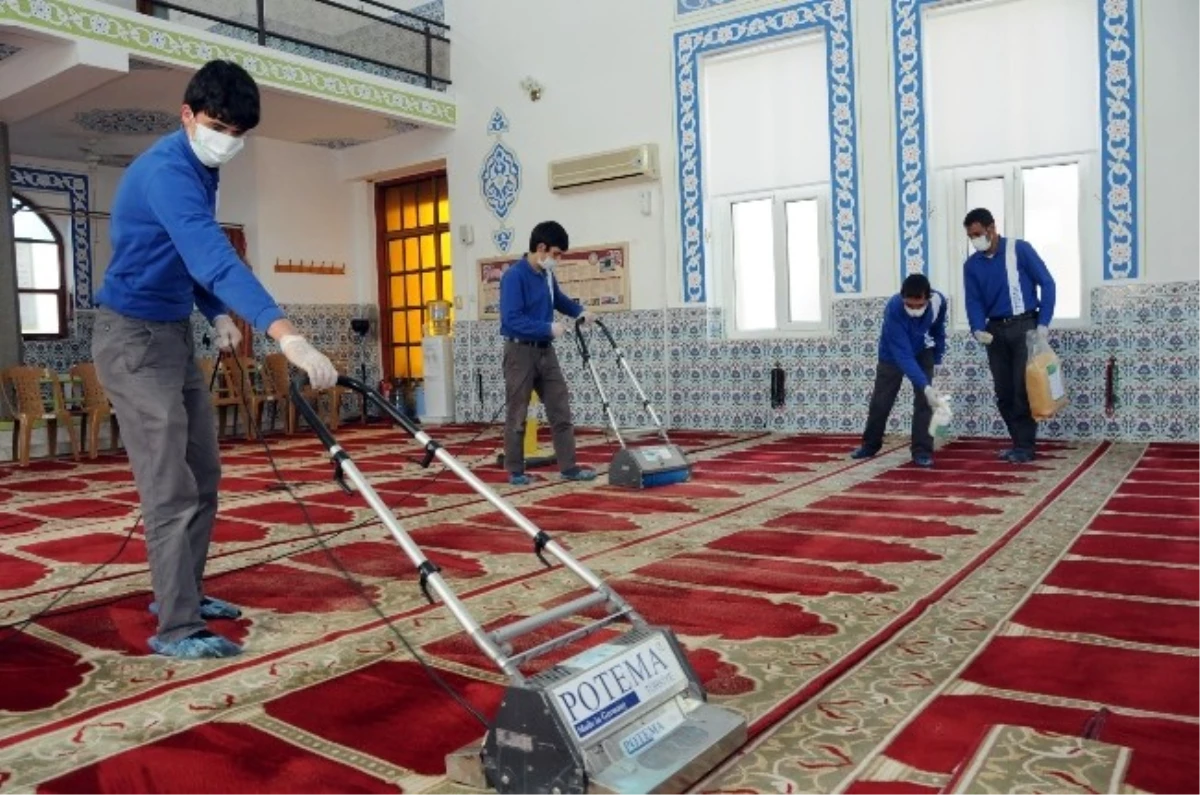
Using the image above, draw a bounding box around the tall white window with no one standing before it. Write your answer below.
[701,34,833,336]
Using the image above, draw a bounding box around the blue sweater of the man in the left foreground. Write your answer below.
[96,130,284,331]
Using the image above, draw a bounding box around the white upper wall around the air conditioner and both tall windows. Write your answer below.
[328,0,1200,319]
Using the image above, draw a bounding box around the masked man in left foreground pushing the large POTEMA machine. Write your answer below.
[92,61,337,659]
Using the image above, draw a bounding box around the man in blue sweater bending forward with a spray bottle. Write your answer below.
[851,274,947,467]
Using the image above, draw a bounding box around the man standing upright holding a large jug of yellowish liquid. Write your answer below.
[962,208,1055,464]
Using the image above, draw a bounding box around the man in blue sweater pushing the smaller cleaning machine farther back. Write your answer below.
[500,221,596,485]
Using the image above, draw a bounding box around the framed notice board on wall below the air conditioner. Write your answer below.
[479,243,630,321]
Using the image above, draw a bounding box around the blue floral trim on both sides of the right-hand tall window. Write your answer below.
[892,0,1140,281]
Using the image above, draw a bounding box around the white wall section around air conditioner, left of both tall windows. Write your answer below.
[341,0,680,318]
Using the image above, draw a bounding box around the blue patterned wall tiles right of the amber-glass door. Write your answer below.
[456,283,1200,449]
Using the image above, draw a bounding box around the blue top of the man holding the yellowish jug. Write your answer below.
[962,238,1055,331]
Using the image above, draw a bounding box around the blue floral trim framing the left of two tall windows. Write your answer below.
[674,0,862,304]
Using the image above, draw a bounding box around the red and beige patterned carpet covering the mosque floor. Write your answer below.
[0,426,1200,794]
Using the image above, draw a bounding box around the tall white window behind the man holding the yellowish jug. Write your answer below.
[923,0,1102,328]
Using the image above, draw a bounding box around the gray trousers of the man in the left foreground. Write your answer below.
[91,309,221,642]
